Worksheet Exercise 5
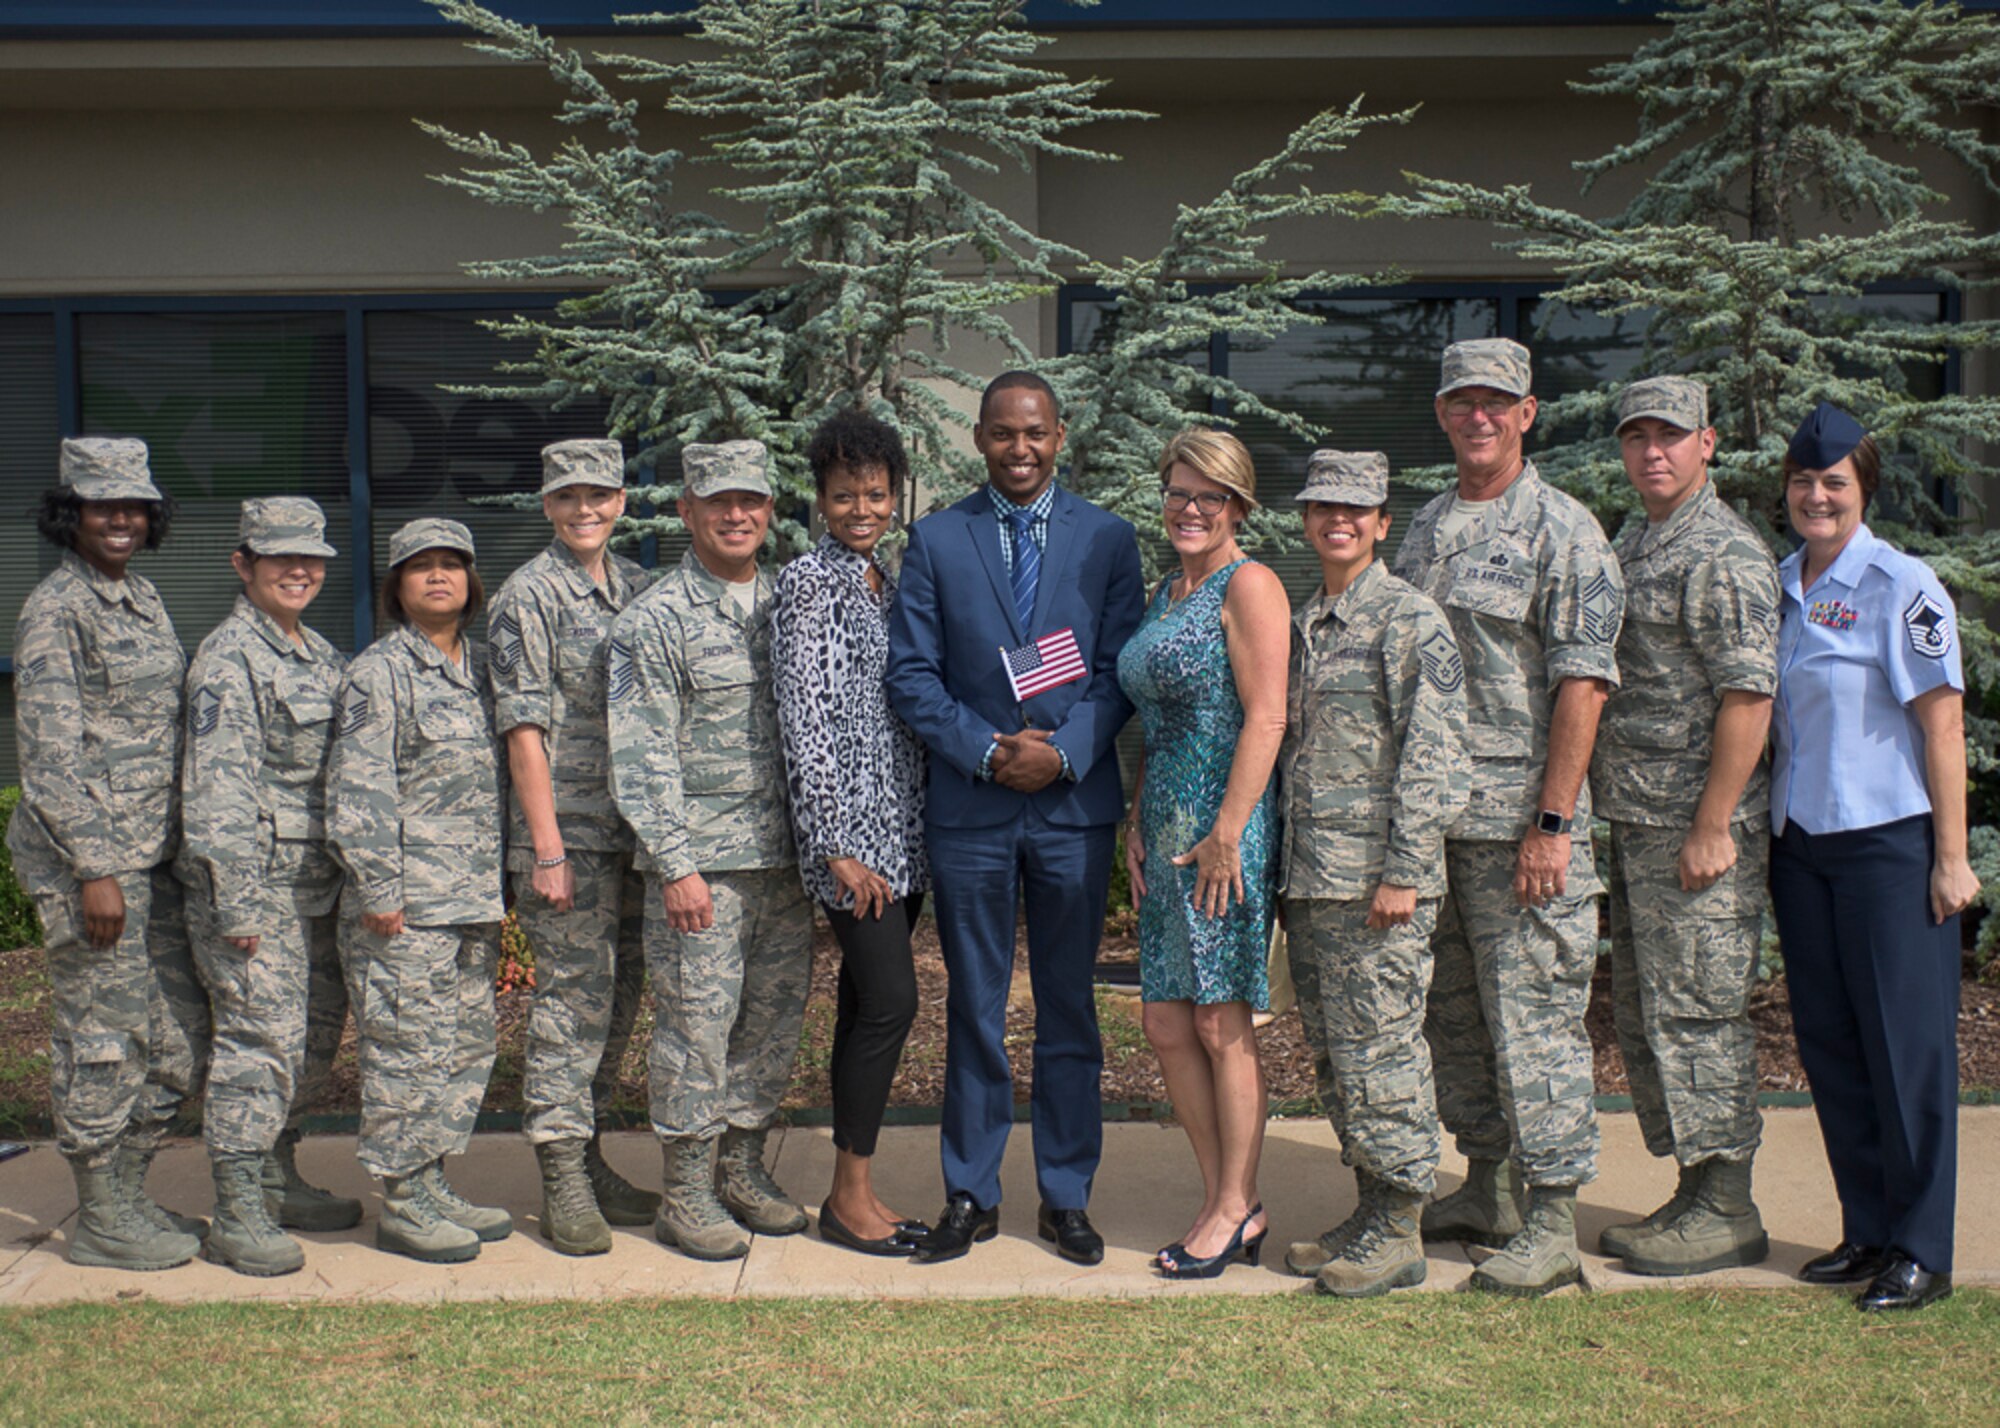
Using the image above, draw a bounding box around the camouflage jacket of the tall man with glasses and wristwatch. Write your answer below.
[1396,462,1624,842]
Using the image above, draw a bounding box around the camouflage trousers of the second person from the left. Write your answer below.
[188,886,348,1154]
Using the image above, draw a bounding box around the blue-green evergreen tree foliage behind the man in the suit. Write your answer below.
[422,0,1410,568]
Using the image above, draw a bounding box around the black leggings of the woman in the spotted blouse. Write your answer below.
[826,892,924,1156]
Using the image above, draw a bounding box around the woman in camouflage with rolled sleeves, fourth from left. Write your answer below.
[486,440,660,1254]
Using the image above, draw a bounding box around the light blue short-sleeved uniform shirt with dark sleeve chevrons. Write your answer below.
[1770,526,1966,834]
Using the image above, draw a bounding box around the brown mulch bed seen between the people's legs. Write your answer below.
[0,922,2000,1130]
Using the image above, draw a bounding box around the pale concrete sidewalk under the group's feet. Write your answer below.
[0,1106,2000,1304]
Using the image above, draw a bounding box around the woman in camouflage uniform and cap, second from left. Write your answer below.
[176,496,362,1274]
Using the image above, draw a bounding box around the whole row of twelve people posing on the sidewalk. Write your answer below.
[8,340,1978,1308]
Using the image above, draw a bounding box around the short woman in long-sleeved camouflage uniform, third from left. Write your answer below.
[326,520,512,1262]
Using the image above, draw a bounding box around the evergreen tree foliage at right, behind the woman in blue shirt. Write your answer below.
[1382,0,2000,954]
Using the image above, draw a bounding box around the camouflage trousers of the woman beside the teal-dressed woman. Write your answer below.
[1284,898,1438,1196]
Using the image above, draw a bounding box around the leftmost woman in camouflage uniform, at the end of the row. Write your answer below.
[8,436,208,1270]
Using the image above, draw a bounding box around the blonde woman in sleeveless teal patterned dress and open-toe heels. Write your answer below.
[1118,430,1292,1278]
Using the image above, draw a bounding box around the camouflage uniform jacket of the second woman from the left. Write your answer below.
[180,596,346,938]
